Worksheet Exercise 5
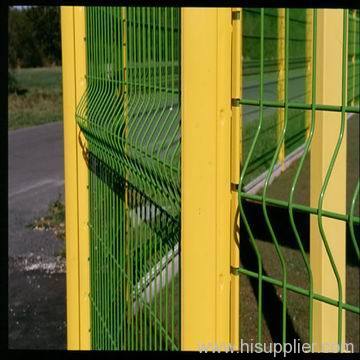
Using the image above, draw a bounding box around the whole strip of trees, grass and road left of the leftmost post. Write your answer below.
[8,6,66,349]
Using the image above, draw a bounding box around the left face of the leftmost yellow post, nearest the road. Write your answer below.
[61,6,80,350]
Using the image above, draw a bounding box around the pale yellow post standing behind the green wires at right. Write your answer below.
[310,9,346,351]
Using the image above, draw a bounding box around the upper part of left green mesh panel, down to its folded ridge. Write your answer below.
[76,7,180,215]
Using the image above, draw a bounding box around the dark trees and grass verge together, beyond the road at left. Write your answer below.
[8,6,62,129]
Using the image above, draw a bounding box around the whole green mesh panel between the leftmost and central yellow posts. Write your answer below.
[76,7,180,350]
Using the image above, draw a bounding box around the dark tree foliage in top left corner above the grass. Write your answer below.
[9,6,61,68]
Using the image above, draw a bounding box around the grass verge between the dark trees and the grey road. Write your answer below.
[8,67,62,130]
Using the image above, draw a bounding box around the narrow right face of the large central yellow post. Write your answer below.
[215,8,232,344]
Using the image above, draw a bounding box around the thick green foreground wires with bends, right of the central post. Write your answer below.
[233,9,360,348]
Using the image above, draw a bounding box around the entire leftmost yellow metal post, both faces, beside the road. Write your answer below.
[61,6,90,350]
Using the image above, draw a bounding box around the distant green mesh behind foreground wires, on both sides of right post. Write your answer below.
[242,8,360,183]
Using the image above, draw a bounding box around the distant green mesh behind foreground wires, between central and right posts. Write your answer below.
[242,8,310,182]
